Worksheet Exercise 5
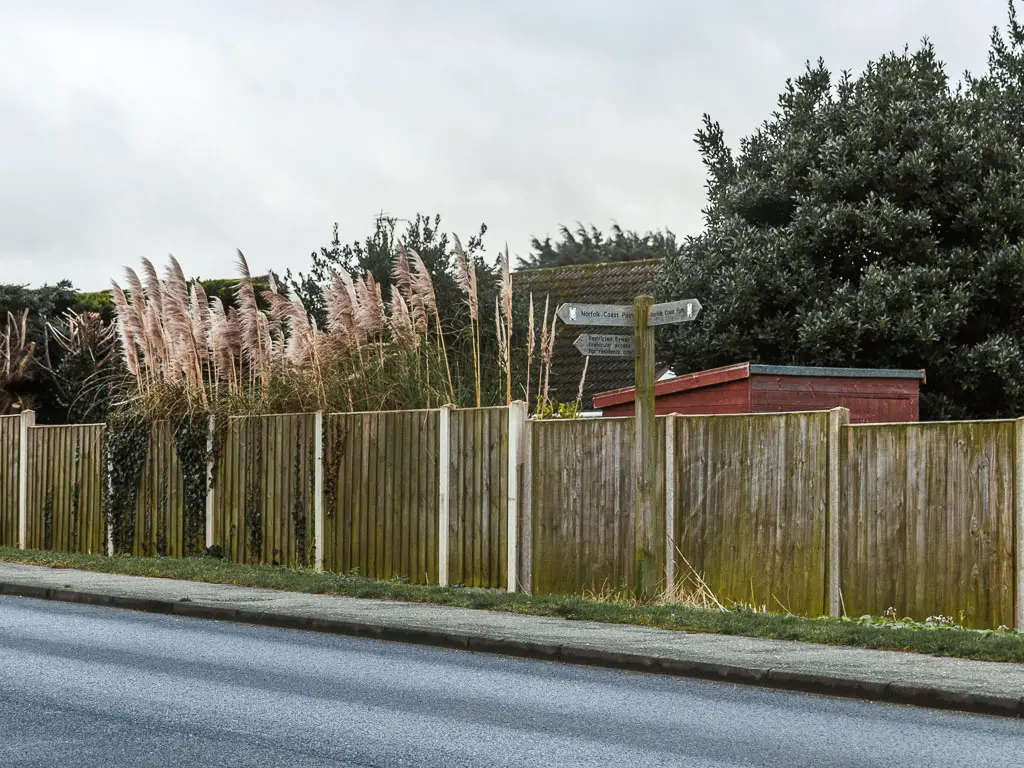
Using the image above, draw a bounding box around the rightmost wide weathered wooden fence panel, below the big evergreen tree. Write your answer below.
[840,421,1020,628]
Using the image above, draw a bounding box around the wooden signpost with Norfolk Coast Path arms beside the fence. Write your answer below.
[556,296,700,599]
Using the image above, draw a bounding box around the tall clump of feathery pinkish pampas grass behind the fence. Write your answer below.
[111,238,554,418]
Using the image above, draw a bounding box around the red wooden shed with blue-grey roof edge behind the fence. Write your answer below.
[594,362,925,424]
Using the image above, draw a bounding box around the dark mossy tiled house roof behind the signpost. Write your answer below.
[512,259,663,409]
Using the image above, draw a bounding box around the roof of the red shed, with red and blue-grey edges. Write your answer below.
[594,362,925,409]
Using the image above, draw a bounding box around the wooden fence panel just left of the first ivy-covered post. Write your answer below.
[27,424,106,554]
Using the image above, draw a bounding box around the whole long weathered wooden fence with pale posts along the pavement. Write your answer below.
[0,403,1024,629]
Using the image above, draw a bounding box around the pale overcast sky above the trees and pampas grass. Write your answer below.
[0,0,1007,290]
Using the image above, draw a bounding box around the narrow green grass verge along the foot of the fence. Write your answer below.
[0,548,1024,663]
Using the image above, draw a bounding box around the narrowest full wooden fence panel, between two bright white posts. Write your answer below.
[449,408,509,589]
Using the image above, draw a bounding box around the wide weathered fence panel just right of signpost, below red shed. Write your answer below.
[675,412,828,615]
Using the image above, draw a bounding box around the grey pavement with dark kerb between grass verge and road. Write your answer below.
[0,563,1024,717]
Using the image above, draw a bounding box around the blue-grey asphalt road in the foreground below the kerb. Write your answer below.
[0,598,1024,768]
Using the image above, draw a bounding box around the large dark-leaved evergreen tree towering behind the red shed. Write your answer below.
[659,2,1024,419]
